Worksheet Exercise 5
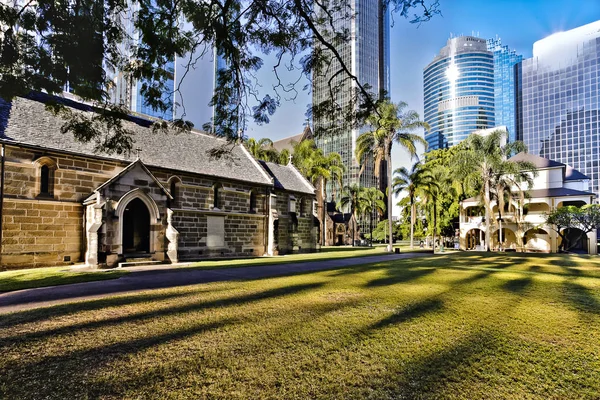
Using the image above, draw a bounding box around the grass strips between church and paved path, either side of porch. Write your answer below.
[0,247,412,293]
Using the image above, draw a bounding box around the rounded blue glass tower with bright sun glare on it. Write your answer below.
[423,36,495,150]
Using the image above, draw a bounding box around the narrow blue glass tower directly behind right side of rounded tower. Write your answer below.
[487,37,523,142]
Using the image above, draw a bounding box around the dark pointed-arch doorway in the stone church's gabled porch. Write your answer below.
[122,198,150,254]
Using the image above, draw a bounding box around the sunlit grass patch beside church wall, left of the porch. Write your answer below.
[0,266,127,293]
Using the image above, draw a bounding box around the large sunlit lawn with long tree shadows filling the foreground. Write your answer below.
[0,253,600,399]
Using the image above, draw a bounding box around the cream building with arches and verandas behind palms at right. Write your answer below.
[460,153,597,254]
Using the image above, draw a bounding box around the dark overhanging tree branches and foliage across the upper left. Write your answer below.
[0,0,439,152]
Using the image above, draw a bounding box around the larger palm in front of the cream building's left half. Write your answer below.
[455,130,536,251]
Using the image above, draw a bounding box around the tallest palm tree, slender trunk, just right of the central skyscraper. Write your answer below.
[356,100,429,252]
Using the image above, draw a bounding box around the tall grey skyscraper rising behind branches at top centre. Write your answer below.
[313,0,390,199]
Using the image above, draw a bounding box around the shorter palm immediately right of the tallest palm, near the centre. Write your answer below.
[392,162,433,249]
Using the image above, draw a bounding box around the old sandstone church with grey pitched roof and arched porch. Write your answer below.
[0,94,318,269]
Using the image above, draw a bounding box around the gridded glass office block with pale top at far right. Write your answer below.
[517,21,600,193]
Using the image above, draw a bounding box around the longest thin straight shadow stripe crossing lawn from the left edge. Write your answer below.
[0,283,323,350]
